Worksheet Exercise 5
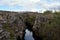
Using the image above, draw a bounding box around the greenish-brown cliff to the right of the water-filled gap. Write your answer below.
[33,14,60,40]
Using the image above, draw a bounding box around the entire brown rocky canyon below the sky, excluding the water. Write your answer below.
[0,11,60,40]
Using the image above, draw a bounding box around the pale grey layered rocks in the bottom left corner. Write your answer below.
[0,24,10,40]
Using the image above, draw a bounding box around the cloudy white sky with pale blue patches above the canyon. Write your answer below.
[0,0,60,12]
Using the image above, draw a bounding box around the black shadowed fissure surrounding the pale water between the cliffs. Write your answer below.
[17,17,43,40]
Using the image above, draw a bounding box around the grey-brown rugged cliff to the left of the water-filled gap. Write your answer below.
[0,12,26,40]
